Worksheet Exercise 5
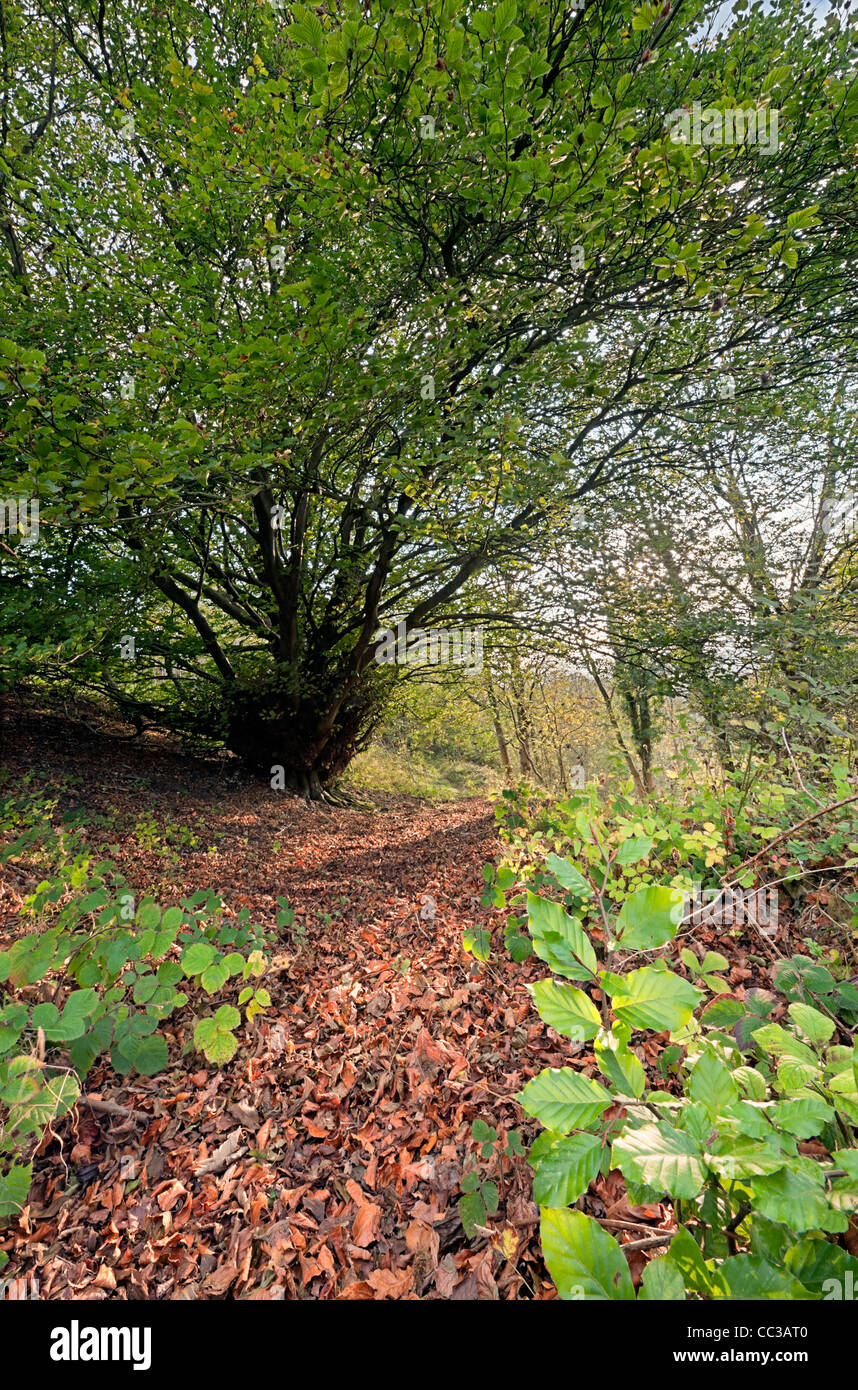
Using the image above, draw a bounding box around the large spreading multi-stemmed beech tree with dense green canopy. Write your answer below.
[0,0,858,796]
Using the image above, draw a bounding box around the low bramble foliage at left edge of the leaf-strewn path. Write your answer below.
[0,806,271,1219]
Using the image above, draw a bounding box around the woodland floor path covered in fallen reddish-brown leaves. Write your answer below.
[0,714,581,1300]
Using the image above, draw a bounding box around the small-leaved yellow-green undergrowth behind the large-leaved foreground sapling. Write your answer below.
[464,781,858,973]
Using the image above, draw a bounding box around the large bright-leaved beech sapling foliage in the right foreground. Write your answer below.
[481,810,858,1300]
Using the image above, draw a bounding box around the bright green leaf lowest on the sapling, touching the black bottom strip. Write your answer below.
[540,1207,634,1302]
